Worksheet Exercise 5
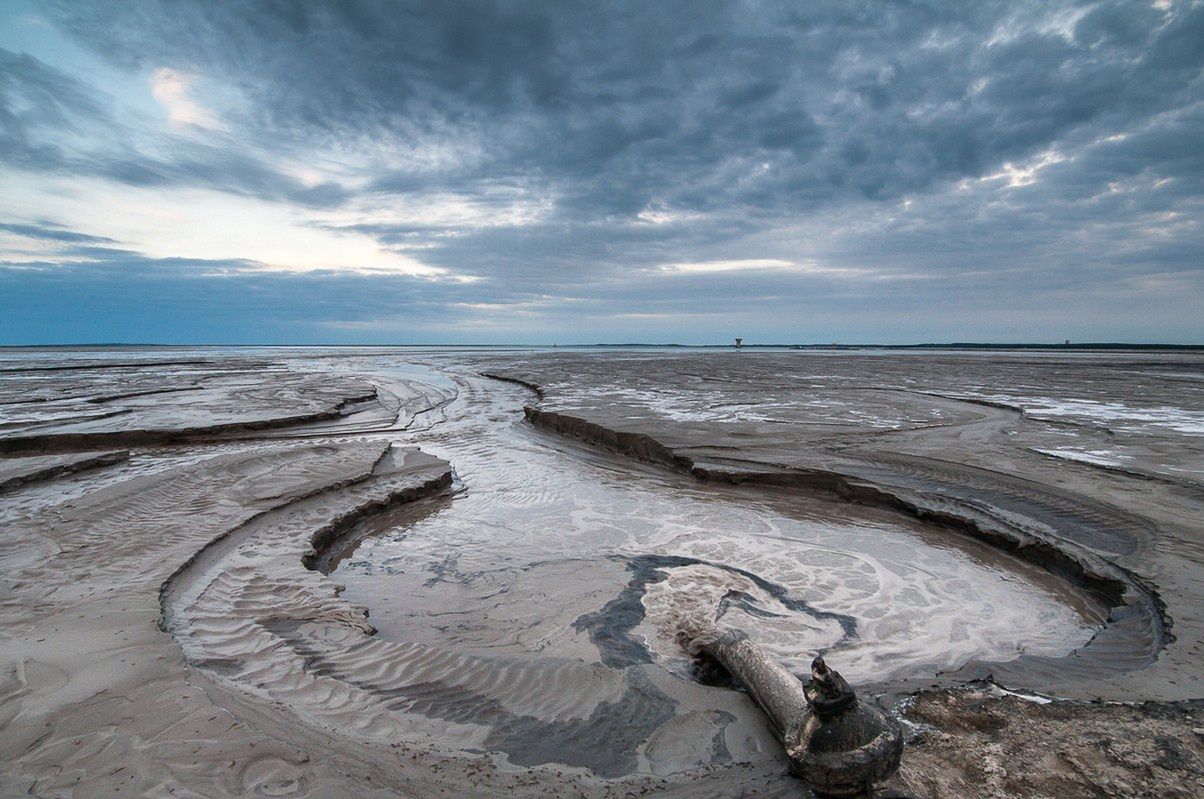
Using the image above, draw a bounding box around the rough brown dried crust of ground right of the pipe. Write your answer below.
[891,687,1204,799]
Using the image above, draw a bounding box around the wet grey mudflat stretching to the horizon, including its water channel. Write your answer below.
[0,350,1204,797]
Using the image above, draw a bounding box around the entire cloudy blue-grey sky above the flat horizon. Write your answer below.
[0,0,1204,344]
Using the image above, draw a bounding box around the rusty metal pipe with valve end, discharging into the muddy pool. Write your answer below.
[684,629,903,797]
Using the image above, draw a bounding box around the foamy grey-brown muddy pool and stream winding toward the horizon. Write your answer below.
[324,359,1100,682]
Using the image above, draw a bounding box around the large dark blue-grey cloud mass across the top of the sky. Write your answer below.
[44,2,1204,217]
